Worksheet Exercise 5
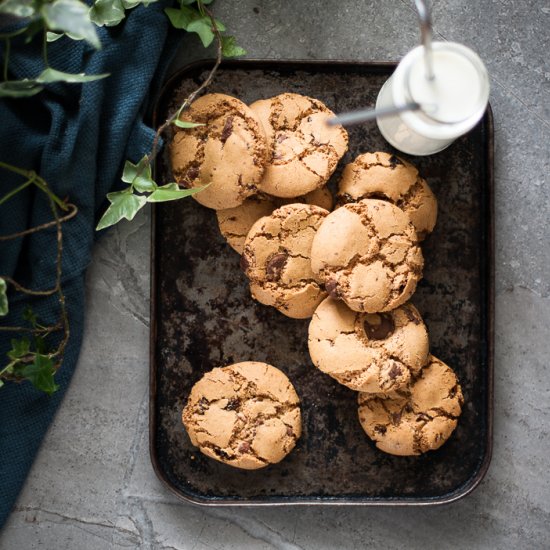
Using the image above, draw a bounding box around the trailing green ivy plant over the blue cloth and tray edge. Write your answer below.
[0,0,246,394]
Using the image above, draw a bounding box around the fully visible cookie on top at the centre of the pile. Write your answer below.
[311,199,424,313]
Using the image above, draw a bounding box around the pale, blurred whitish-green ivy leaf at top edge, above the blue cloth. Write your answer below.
[40,0,101,50]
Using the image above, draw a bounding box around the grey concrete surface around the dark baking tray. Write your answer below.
[0,0,550,550]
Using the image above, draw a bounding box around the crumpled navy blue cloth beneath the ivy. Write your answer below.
[0,2,177,527]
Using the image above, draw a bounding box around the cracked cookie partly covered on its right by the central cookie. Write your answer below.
[241,204,328,319]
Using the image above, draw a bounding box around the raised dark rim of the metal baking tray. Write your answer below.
[149,58,495,507]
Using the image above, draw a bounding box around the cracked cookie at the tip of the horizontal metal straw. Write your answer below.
[250,93,348,198]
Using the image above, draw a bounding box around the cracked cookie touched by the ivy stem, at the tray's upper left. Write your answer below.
[170,94,267,209]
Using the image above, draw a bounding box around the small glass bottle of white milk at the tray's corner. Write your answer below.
[376,42,489,155]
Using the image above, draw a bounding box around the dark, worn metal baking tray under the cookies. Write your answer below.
[150,60,494,505]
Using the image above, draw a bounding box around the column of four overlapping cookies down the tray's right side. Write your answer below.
[308,153,463,456]
